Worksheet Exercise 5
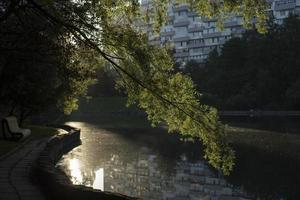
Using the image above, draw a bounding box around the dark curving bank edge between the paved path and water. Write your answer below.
[31,126,137,200]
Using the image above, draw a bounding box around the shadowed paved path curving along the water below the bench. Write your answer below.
[0,139,47,200]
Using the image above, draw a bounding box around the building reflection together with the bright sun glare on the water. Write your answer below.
[60,148,251,200]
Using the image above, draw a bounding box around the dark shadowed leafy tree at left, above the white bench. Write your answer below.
[0,1,94,123]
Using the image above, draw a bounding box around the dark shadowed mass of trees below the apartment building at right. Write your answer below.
[186,16,300,110]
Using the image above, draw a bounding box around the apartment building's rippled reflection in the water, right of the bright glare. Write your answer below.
[97,148,250,200]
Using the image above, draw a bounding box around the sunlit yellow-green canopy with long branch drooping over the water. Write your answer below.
[0,0,267,174]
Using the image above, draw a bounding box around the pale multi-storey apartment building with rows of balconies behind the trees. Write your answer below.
[141,0,300,62]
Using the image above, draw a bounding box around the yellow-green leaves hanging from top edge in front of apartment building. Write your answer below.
[154,0,269,33]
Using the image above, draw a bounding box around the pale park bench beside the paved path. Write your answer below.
[2,116,31,140]
